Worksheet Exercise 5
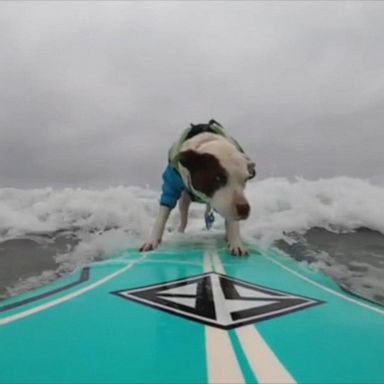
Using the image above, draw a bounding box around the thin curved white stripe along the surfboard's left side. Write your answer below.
[0,255,147,326]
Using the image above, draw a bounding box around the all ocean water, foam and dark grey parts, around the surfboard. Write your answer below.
[0,177,384,304]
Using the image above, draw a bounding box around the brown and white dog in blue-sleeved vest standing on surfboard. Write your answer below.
[140,120,256,255]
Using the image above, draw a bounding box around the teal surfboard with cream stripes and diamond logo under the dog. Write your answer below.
[0,242,384,383]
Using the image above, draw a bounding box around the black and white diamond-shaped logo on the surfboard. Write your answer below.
[112,272,323,329]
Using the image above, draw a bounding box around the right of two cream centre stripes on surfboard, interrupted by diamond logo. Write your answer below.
[211,251,296,384]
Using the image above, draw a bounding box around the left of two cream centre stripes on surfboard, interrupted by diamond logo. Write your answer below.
[203,251,245,384]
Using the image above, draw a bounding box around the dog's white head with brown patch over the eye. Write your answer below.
[177,133,256,220]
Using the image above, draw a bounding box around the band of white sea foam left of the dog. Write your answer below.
[0,187,156,239]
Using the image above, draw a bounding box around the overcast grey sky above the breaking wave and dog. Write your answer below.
[0,1,384,188]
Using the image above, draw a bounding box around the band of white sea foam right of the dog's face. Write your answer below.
[243,177,384,247]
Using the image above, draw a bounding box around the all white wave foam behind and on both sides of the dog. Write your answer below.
[0,177,384,304]
